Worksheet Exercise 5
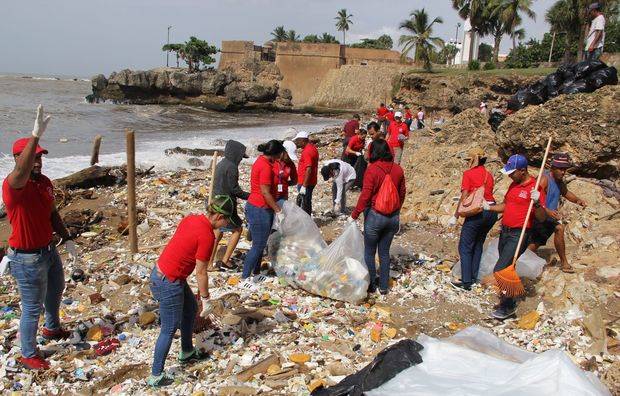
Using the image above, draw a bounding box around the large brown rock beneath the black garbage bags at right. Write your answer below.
[497,86,620,179]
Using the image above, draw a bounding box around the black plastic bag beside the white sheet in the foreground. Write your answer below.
[312,340,423,396]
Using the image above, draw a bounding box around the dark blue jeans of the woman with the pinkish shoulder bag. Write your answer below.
[459,210,497,285]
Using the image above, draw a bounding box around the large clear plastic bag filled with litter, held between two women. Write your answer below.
[267,202,370,304]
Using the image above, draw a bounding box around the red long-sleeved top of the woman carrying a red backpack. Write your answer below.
[351,161,407,219]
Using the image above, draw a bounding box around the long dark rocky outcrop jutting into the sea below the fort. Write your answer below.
[87,65,291,110]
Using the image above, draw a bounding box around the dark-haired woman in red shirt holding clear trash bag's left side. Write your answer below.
[241,140,286,279]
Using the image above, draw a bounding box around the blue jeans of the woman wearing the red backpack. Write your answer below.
[364,209,400,290]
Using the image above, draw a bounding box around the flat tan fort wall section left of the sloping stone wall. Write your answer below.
[276,43,344,105]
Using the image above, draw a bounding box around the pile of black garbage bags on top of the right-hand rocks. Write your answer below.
[508,60,618,111]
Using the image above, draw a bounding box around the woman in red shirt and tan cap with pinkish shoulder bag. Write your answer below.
[449,148,497,290]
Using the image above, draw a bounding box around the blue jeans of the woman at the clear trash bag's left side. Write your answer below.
[241,202,273,279]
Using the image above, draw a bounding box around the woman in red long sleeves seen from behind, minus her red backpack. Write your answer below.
[349,139,406,294]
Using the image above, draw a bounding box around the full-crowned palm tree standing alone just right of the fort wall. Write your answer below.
[398,8,443,71]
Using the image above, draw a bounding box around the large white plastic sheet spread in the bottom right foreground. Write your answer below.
[366,327,610,396]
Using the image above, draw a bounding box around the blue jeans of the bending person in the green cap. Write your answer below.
[151,265,198,375]
